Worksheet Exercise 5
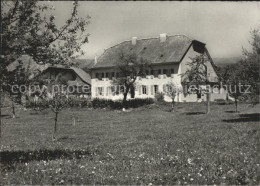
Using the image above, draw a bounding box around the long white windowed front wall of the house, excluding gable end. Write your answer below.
[91,63,181,101]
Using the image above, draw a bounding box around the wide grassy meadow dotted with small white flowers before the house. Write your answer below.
[0,103,260,185]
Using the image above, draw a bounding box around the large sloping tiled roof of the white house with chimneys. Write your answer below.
[93,35,205,68]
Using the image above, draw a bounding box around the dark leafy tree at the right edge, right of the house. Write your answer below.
[219,30,260,112]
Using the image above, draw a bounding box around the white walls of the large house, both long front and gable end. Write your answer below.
[91,47,226,102]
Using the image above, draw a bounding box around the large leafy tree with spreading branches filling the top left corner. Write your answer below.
[0,0,90,135]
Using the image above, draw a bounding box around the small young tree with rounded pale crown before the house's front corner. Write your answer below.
[164,82,182,112]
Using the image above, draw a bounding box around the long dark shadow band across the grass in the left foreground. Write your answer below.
[0,149,91,166]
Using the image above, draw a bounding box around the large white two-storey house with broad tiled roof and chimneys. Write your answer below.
[91,34,222,102]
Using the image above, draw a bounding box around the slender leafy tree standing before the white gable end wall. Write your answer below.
[181,54,211,113]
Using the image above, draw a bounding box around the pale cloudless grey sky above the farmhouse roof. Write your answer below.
[49,1,260,58]
